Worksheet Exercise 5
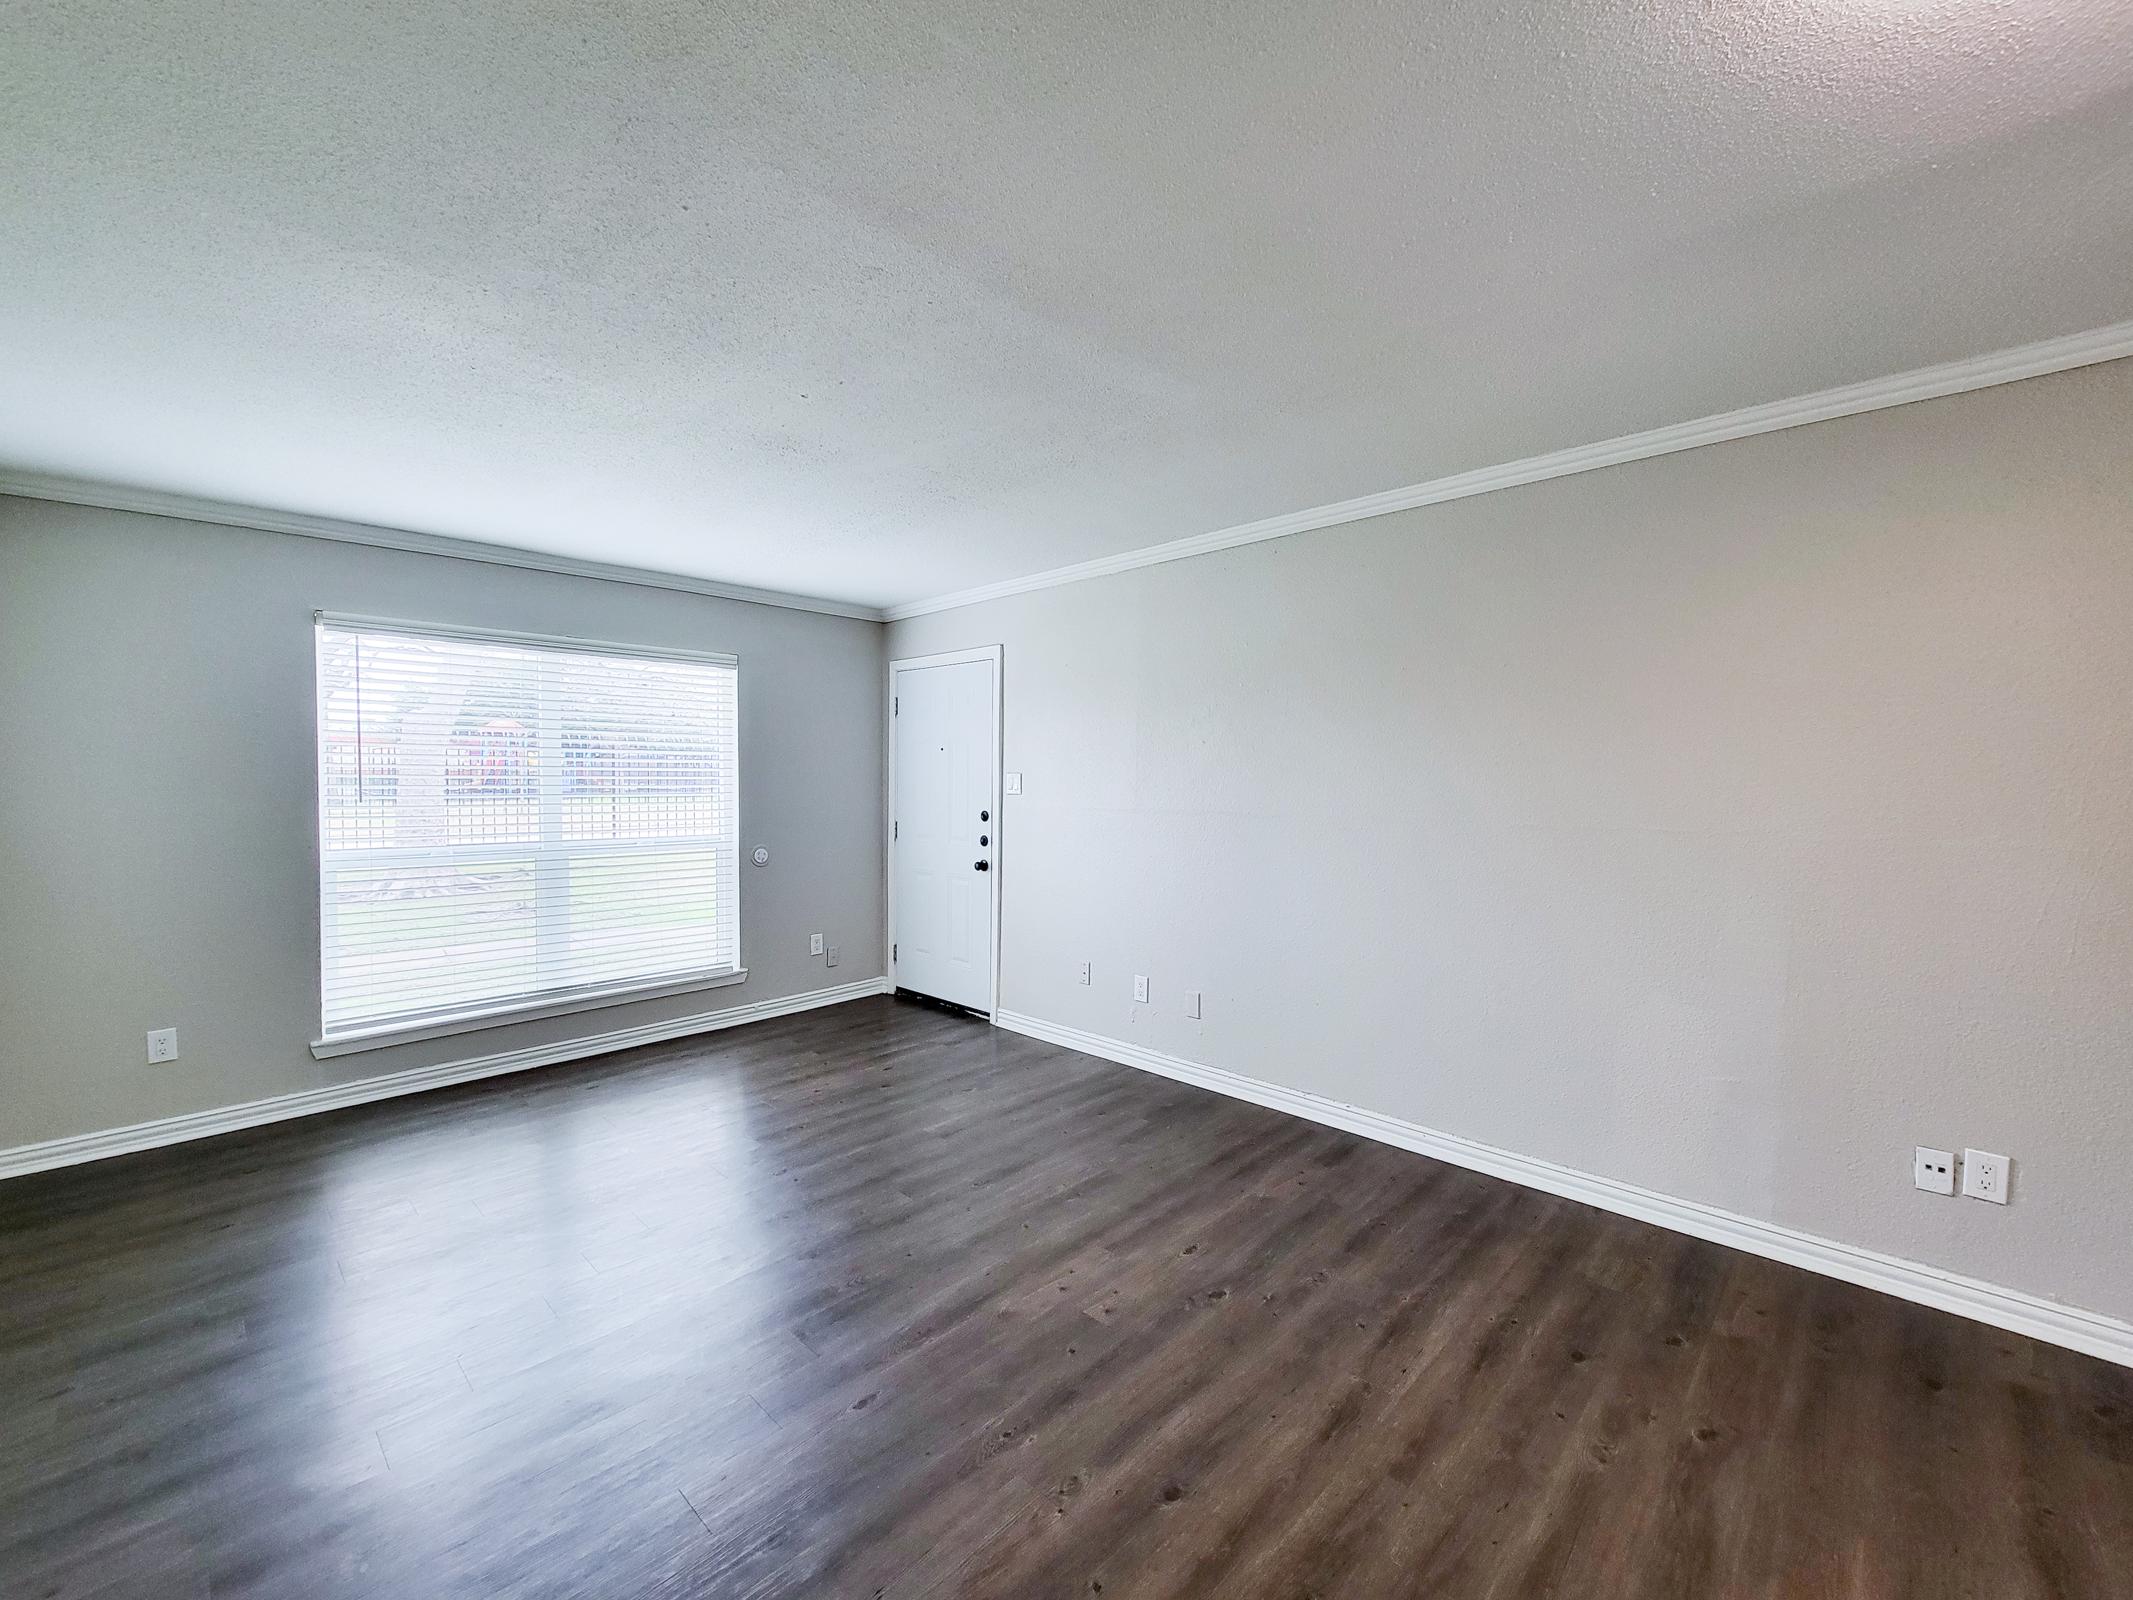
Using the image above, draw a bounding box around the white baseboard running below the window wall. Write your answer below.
[0,977,889,1180]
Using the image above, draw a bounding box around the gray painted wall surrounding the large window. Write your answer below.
[0,499,883,1148]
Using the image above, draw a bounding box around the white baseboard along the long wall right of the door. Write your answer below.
[992,1011,2133,1367]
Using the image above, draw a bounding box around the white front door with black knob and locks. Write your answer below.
[889,651,1000,1013]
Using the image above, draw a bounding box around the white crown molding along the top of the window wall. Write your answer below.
[0,469,883,623]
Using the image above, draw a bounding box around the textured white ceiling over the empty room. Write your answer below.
[0,0,2133,604]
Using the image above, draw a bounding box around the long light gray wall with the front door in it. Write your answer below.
[889,363,2133,1316]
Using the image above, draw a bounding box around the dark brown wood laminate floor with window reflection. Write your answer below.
[0,1001,2133,1600]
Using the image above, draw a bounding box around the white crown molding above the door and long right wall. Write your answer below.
[881,322,2133,623]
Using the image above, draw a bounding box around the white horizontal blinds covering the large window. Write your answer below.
[318,617,740,1041]
